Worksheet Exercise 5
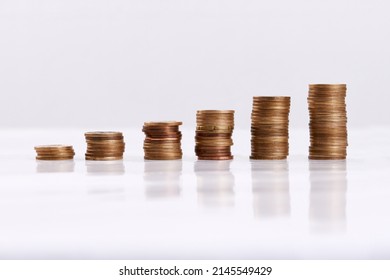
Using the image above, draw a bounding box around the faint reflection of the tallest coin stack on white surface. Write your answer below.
[309,160,348,233]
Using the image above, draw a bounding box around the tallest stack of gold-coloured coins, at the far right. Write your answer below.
[308,84,348,159]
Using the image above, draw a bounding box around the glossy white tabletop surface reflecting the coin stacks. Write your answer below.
[0,127,390,259]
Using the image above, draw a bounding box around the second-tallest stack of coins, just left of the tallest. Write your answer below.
[250,96,290,160]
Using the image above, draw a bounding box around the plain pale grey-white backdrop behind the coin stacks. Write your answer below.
[0,0,390,128]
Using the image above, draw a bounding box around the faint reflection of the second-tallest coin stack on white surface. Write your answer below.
[251,160,290,219]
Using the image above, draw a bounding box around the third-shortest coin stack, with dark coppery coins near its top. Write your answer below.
[142,121,183,160]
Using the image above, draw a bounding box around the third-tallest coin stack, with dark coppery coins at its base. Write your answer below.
[195,110,234,160]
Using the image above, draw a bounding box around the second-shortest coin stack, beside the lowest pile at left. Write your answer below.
[84,131,125,160]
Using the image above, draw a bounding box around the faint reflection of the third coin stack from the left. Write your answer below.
[144,160,182,198]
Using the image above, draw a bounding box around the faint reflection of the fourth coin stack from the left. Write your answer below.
[194,160,234,207]
